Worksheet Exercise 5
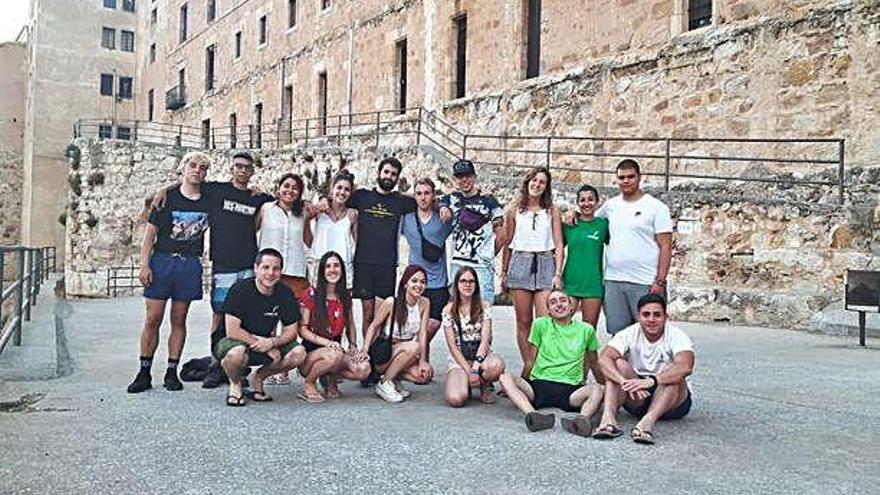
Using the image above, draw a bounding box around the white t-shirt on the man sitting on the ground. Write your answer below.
[608,323,694,376]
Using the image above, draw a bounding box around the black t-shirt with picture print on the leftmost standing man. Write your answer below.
[148,186,211,256]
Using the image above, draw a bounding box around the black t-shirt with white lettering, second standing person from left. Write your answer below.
[202,182,275,273]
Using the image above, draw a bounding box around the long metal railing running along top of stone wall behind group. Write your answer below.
[74,107,846,204]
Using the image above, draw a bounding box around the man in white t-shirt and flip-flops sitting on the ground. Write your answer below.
[593,294,694,444]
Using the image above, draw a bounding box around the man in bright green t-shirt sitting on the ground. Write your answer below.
[501,289,605,437]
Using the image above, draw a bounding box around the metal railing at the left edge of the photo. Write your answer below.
[0,246,56,353]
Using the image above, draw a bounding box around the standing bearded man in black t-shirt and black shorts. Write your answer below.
[347,157,417,338]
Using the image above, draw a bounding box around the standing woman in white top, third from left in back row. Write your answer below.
[258,173,312,299]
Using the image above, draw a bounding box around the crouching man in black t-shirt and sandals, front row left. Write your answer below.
[216,248,306,407]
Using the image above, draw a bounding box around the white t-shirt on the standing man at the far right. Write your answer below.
[596,194,672,285]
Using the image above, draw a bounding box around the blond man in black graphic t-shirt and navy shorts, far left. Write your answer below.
[128,152,211,393]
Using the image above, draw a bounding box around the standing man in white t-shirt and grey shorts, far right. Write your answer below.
[596,159,672,335]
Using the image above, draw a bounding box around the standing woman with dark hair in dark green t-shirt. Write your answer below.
[562,185,609,328]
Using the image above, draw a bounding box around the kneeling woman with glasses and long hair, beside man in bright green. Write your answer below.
[442,266,504,407]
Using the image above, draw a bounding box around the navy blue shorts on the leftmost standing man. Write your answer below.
[144,253,202,301]
